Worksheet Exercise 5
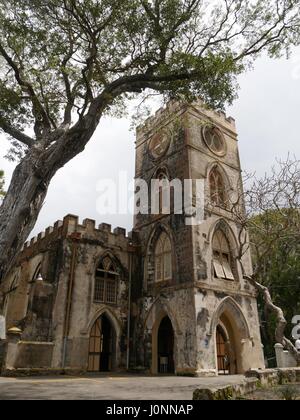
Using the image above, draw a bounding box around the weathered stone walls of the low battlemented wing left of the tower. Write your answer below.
[2,215,138,370]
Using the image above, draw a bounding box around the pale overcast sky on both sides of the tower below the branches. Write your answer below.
[0,49,300,240]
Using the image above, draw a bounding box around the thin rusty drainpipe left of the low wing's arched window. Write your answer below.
[62,234,79,369]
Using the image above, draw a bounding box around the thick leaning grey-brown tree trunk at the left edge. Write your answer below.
[0,108,102,284]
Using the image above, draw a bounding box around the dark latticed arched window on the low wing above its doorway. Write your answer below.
[94,257,119,304]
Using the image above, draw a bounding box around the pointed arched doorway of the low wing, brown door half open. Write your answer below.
[88,314,116,372]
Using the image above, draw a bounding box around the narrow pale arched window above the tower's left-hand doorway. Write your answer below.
[155,233,172,282]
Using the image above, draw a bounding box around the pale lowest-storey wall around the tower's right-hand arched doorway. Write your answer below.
[195,289,265,376]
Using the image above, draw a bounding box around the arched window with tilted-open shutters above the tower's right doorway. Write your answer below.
[212,230,234,280]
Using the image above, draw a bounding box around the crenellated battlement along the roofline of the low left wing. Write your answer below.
[22,214,134,252]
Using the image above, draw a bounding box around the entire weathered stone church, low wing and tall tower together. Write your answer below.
[0,101,264,376]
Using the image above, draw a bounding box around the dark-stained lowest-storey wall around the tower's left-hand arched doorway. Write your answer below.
[134,285,197,375]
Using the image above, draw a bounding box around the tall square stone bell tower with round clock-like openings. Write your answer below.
[133,101,264,376]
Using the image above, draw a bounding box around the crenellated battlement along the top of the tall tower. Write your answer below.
[136,99,236,137]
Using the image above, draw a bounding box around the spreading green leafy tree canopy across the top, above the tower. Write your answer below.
[0,0,300,156]
